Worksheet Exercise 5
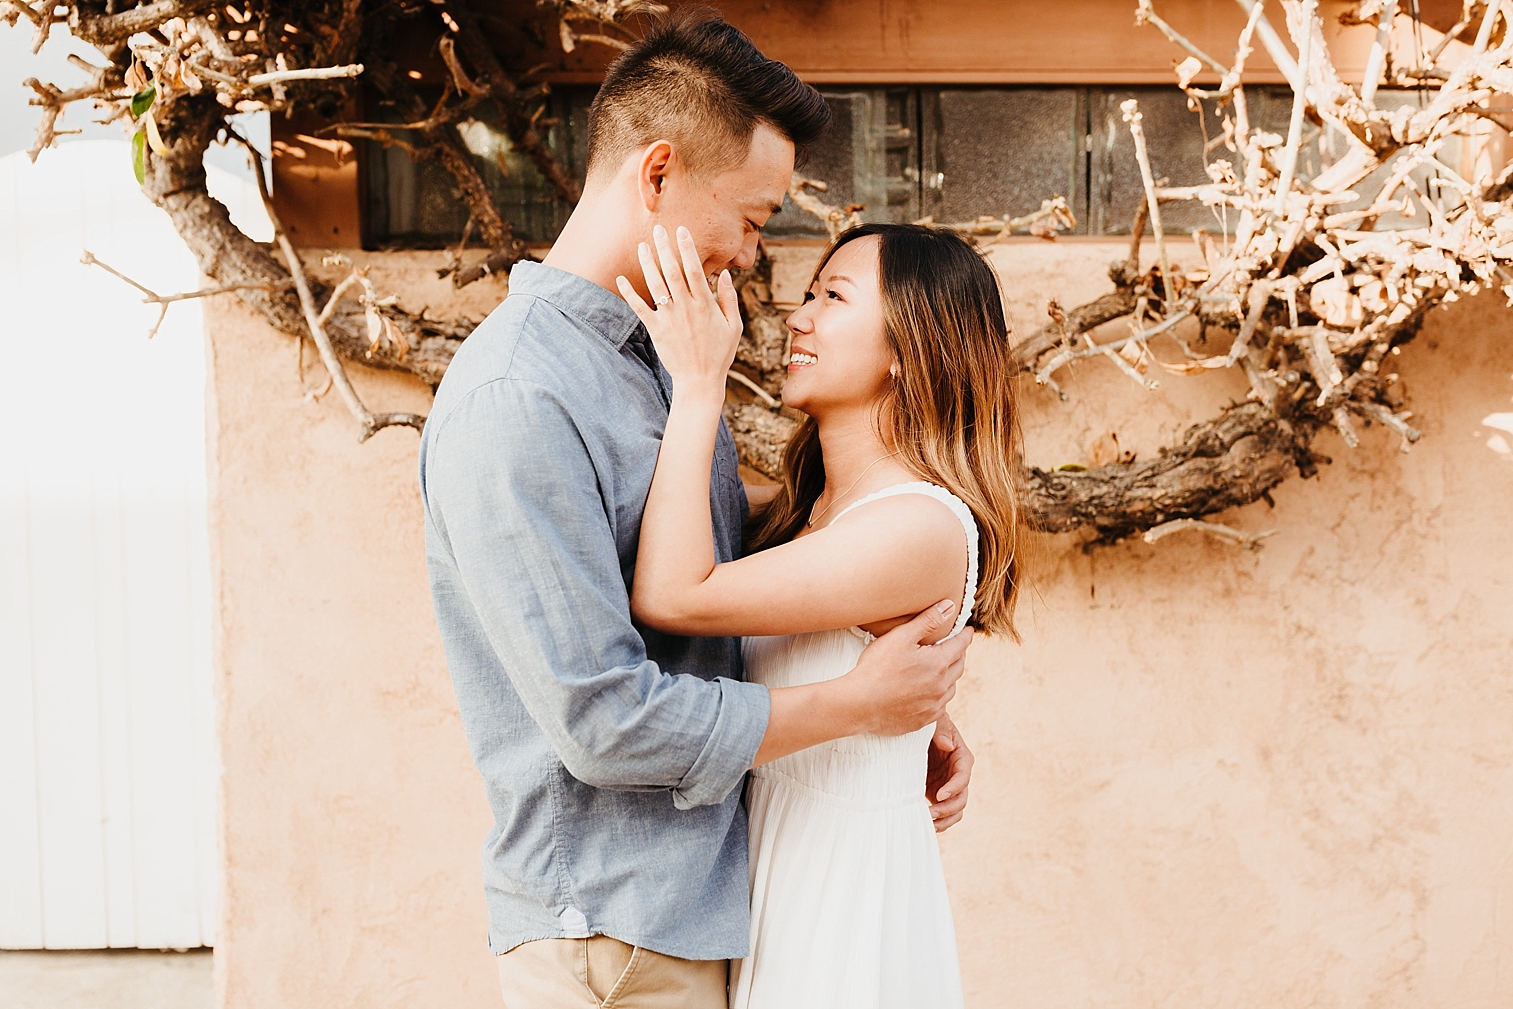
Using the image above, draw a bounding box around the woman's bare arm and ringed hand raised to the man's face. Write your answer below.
[622,228,967,635]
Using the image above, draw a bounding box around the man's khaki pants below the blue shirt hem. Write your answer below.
[495,935,729,1009]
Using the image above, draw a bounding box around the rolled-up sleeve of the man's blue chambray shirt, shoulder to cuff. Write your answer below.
[425,378,770,809]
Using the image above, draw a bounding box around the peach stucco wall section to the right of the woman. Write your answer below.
[943,245,1513,1009]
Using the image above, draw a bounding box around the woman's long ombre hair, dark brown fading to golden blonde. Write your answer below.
[747,224,1024,640]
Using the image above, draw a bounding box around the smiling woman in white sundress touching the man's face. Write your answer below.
[620,224,1020,1009]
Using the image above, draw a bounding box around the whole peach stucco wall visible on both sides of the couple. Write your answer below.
[207,242,1513,1009]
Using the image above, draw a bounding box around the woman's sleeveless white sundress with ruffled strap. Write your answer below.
[731,481,977,1009]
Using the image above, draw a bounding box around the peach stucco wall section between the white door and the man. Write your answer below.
[206,256,502,1009]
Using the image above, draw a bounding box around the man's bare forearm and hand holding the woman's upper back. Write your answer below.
[752,601,971,765]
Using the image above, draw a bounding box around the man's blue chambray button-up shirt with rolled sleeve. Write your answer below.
[421,263,770,959]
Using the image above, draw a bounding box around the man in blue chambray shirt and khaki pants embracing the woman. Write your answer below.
[421,15,971,1009]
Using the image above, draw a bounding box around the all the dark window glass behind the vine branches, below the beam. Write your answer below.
[363,85,1471,248]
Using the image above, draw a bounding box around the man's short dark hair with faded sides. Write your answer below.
[589,9,831,177]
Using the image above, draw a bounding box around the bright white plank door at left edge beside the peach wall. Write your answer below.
[0,141,266,948]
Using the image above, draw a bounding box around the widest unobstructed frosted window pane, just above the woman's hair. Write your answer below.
[923,88,1085,231]
